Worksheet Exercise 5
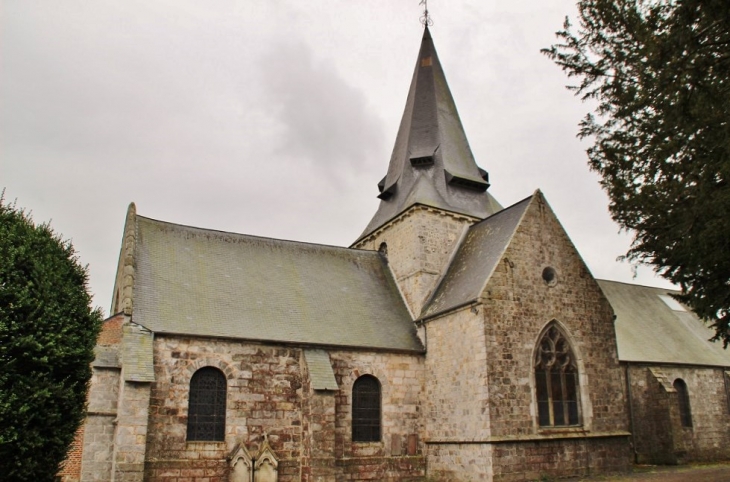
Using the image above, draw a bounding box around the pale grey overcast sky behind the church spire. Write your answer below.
[0,0,669,311]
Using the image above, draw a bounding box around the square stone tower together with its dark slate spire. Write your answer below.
[352,27,502,317]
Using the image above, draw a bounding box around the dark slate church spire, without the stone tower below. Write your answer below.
[361,25,501,237]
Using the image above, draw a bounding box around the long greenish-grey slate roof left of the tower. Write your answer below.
[133,216,423,352]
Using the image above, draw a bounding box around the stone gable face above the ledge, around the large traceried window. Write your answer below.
[483,193,628,437]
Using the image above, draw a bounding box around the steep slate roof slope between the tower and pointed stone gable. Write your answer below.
[421,196,534,318]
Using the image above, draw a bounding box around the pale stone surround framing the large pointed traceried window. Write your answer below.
[529,318,593,435]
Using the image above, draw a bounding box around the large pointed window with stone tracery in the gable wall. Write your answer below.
[535,325,580,427]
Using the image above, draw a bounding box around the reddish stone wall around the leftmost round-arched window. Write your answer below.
[145,335,302,482]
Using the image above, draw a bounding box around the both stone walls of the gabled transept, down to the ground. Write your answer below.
[423,193,630,480]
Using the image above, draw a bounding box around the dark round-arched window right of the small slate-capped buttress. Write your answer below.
[352,375,380,442]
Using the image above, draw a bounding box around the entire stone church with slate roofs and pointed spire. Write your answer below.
[67,27,730,482]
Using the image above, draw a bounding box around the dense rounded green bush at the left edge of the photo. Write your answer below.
[0,196,101,481]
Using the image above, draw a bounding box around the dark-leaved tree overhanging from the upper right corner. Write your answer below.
[543,0,730,347]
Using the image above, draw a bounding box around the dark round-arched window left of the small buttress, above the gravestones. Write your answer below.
[188,367,226,441]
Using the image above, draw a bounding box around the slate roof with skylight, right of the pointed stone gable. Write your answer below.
[597,280,730,367]
